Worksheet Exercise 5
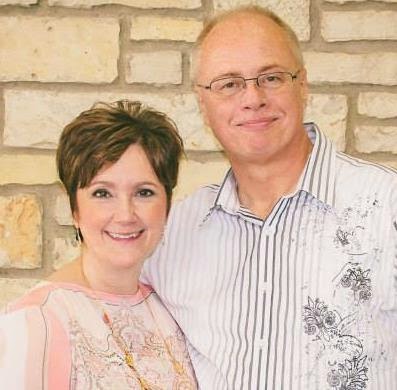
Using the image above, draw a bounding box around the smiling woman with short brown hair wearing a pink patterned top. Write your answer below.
[0,101,196,390]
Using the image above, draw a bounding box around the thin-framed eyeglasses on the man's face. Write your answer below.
[197,70,300,96]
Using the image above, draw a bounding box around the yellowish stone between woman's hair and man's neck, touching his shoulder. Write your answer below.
[174,158,230,200]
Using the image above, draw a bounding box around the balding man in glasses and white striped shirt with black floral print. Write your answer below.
[142,6,397,390]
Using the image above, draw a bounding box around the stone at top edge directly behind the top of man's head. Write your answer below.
[214,0,310,41]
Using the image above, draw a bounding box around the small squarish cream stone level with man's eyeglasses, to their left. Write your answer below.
[126,50,182,84]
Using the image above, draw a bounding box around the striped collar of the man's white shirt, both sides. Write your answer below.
[204,123,336,221]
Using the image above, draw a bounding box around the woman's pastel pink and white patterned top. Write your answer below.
[0,282,197,390]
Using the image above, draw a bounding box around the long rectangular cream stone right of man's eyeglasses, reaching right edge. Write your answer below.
[304,52,397,85]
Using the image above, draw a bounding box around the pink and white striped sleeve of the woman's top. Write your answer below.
[0,306,71,390]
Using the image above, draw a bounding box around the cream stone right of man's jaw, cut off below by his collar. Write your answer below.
[305,94,347,151]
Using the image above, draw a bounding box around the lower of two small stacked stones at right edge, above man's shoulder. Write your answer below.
[354,125,397,153]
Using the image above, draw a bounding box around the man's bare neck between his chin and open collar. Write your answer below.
[231,137,313,219]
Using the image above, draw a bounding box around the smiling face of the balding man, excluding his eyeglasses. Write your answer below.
[196,14,307,163]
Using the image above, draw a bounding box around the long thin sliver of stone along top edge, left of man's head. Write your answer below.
[48,0,201,9]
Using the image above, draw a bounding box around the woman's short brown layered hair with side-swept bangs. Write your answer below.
[56,100,183,213]
